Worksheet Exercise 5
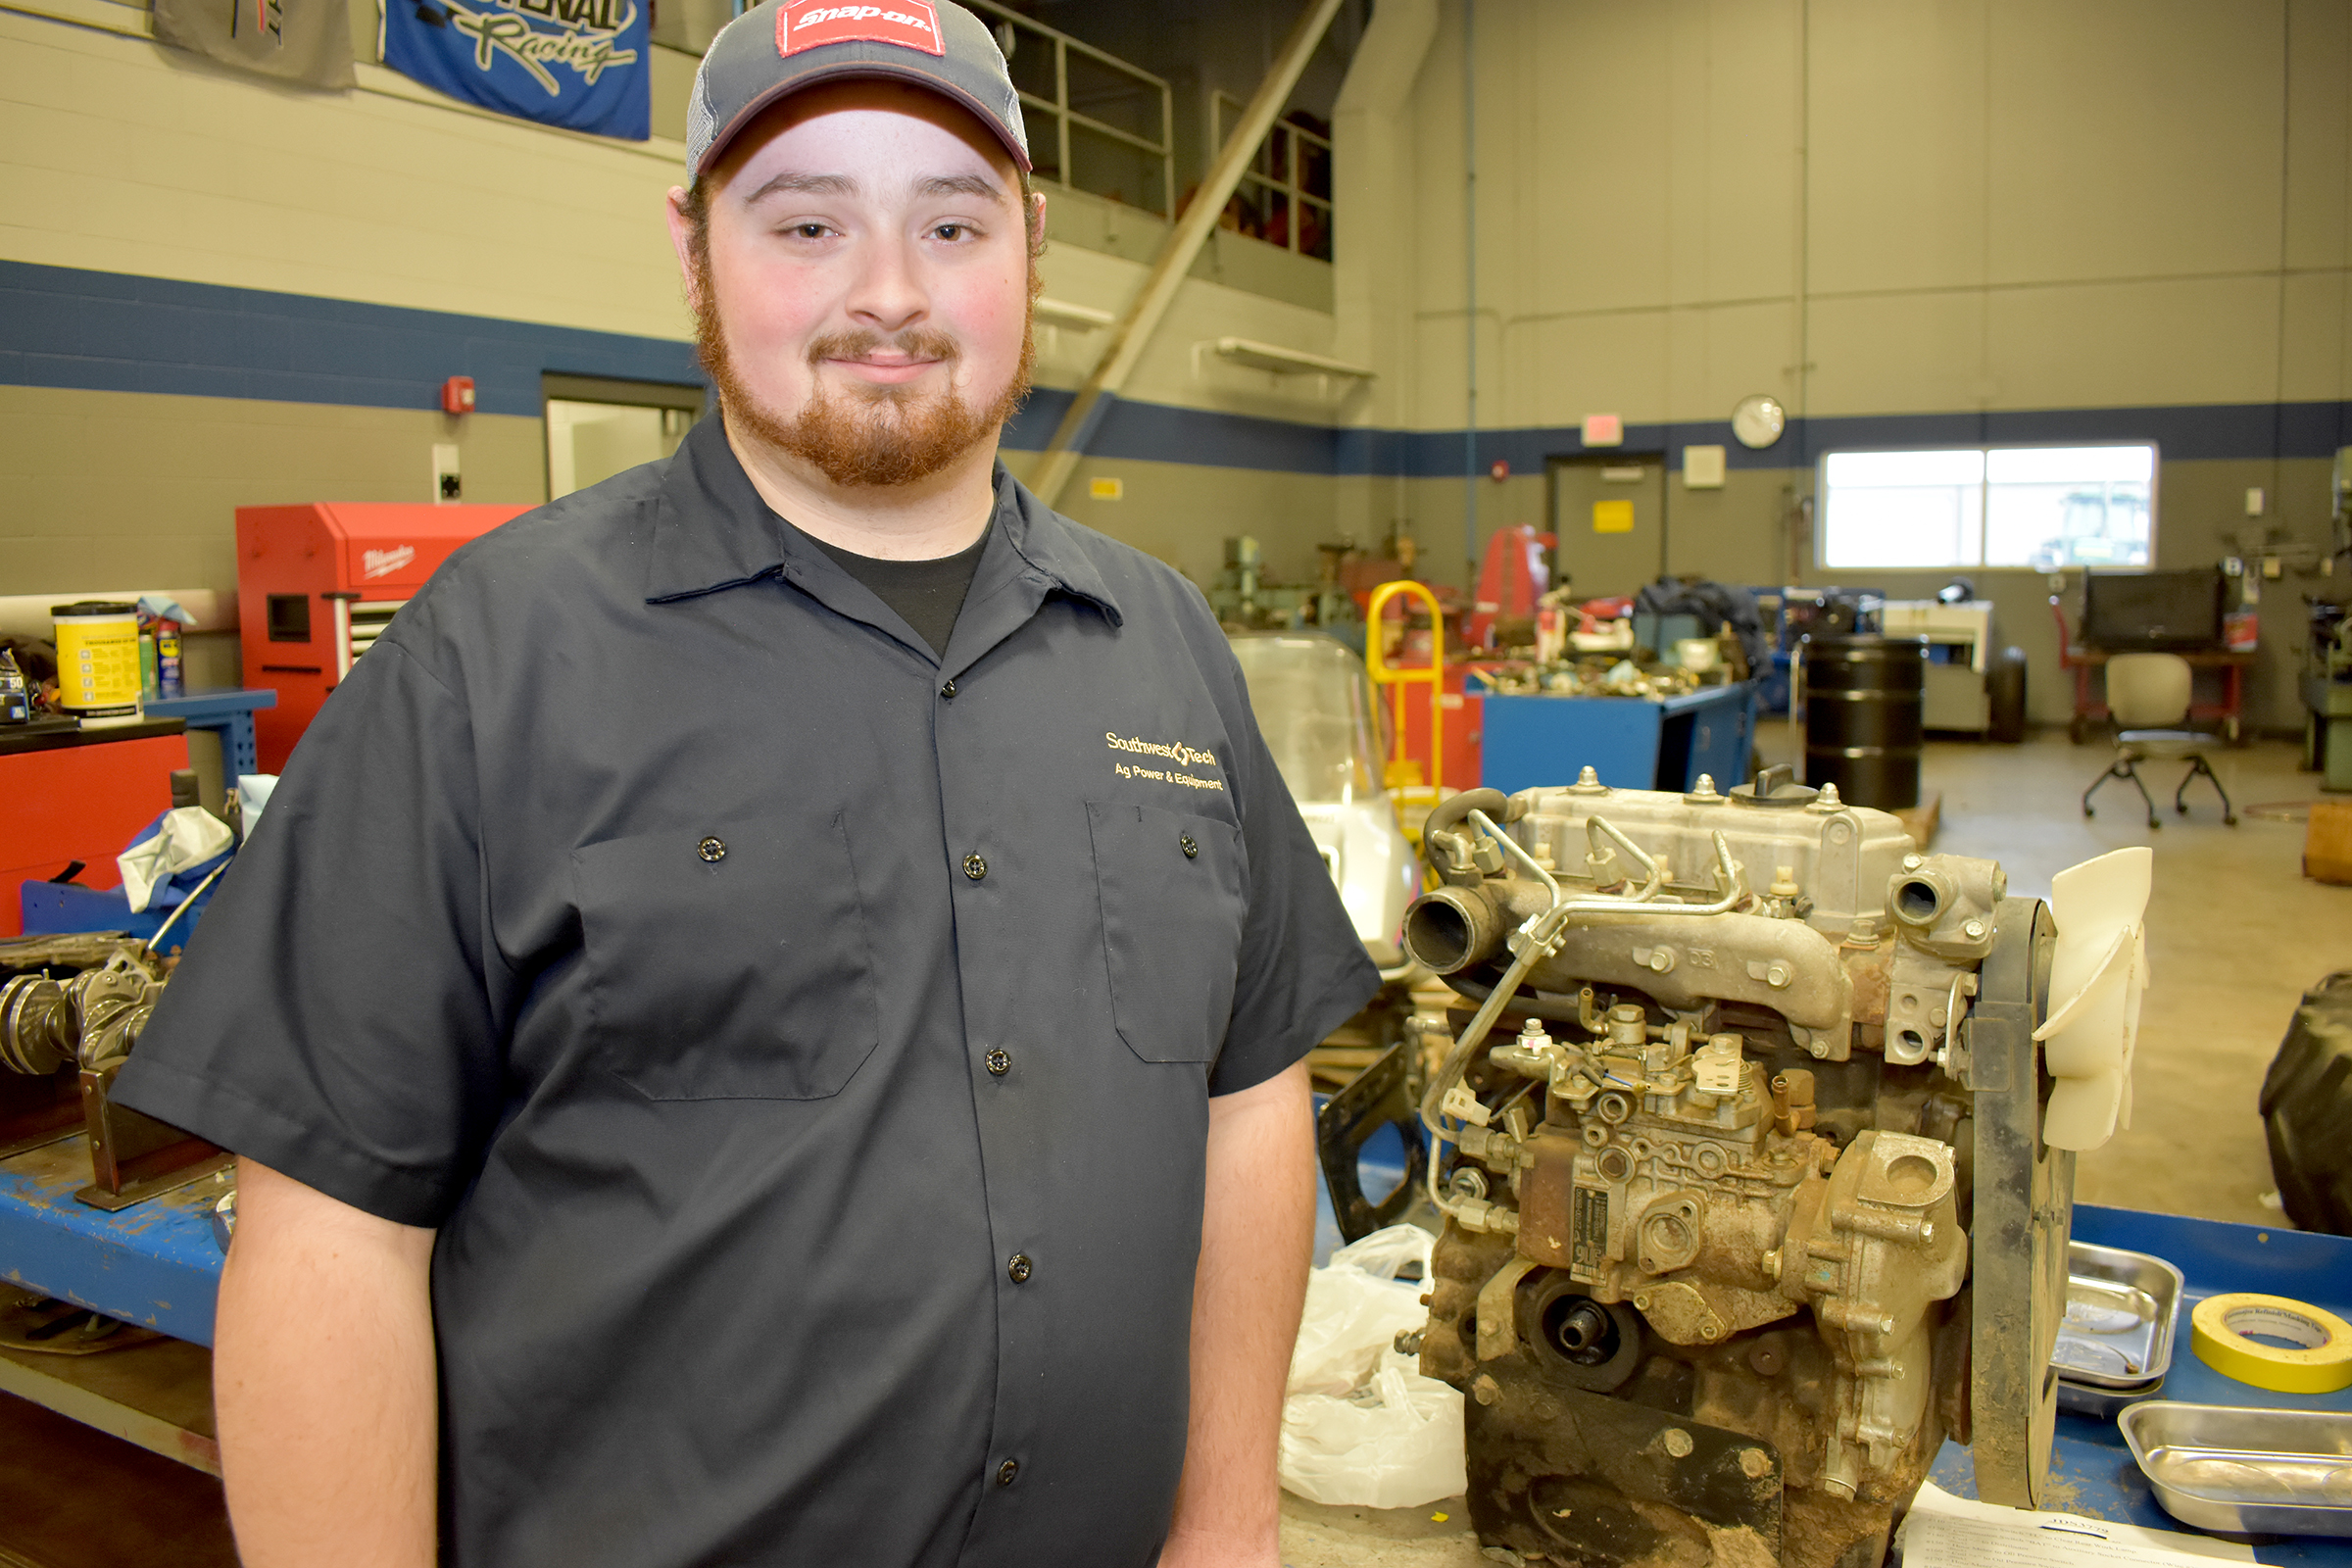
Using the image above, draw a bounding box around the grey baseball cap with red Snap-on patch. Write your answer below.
[687,0,1030,178]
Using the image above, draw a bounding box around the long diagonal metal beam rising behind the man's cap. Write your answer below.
[1030,0,1341,506]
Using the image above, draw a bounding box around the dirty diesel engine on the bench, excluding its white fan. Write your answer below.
[1404,768,2107,1568]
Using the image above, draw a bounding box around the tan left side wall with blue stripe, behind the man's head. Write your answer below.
[0,0,1343,629]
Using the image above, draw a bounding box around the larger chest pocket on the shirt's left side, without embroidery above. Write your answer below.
[571,813,880,1101]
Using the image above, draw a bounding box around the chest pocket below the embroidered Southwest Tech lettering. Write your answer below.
[1087,802,1249,1062]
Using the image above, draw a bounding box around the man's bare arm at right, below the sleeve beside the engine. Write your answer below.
[1159,1065,1315,1568]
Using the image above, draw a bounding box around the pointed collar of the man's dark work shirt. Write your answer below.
[645,409,1124,625]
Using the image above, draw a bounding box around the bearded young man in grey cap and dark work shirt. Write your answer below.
[120,0,1376,1568]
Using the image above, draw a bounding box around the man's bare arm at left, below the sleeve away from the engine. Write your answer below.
[212,1161,440,1568]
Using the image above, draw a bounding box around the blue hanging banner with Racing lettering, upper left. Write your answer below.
[383,0,652,141]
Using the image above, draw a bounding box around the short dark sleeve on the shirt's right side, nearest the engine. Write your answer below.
[1209,637,1381,1096]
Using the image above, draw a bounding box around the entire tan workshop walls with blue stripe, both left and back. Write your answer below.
[0,0,2352,724]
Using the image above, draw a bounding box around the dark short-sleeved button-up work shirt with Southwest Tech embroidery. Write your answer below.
[118,418,1376,1568]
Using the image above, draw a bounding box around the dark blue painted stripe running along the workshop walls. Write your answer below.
[0,261,2352,479]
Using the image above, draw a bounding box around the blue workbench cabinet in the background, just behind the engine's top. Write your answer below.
[1480,682,1757,795]
